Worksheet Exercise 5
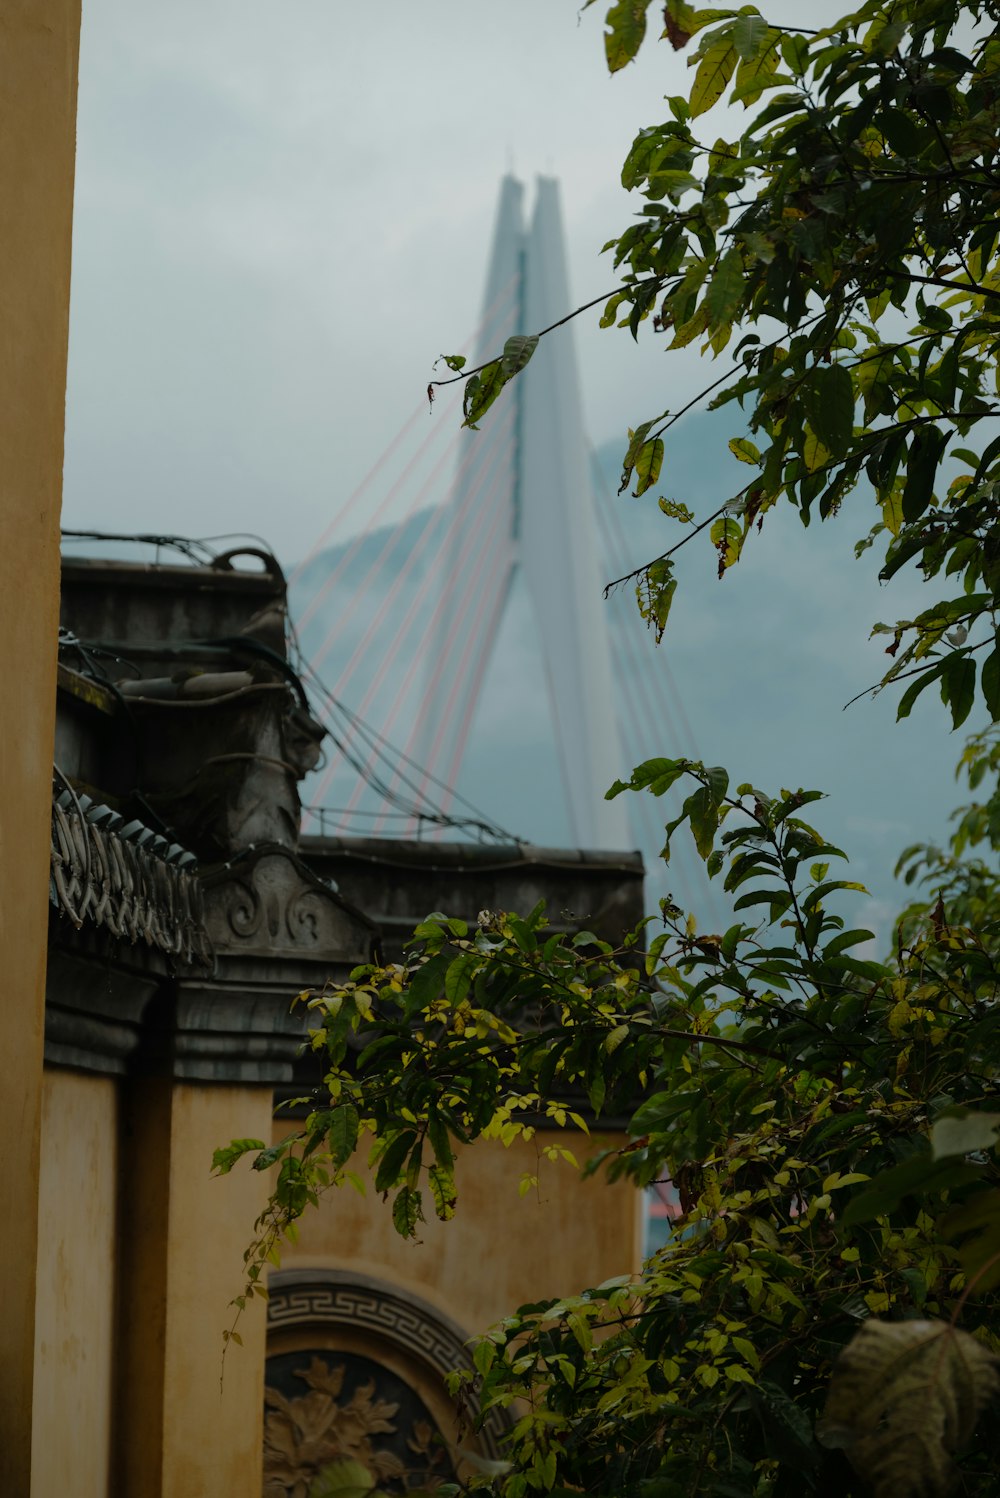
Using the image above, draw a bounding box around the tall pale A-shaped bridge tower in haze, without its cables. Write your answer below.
[416,177,630,849]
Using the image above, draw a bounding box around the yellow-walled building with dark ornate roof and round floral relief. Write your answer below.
[43,551,642,1498]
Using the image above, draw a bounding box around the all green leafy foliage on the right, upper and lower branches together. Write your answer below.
[217,0,1000,1498]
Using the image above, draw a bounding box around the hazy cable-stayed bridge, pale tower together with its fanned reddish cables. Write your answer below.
[290,177,709,894]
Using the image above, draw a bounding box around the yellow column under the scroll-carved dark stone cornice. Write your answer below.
[112,1080,272,1498]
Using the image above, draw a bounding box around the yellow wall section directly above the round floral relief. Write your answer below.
[275,1121,642,1335]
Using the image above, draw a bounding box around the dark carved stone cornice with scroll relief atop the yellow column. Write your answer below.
[45,844,377,1091]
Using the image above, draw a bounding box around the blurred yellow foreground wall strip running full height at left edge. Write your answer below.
[0,0,79,1498]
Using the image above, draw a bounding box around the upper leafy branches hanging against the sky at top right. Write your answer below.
[452,0,1000,725]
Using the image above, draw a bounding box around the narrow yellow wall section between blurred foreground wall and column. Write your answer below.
[31,1071,118,1498]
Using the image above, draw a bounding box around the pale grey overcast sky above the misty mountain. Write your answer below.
[64,0,835,562]
